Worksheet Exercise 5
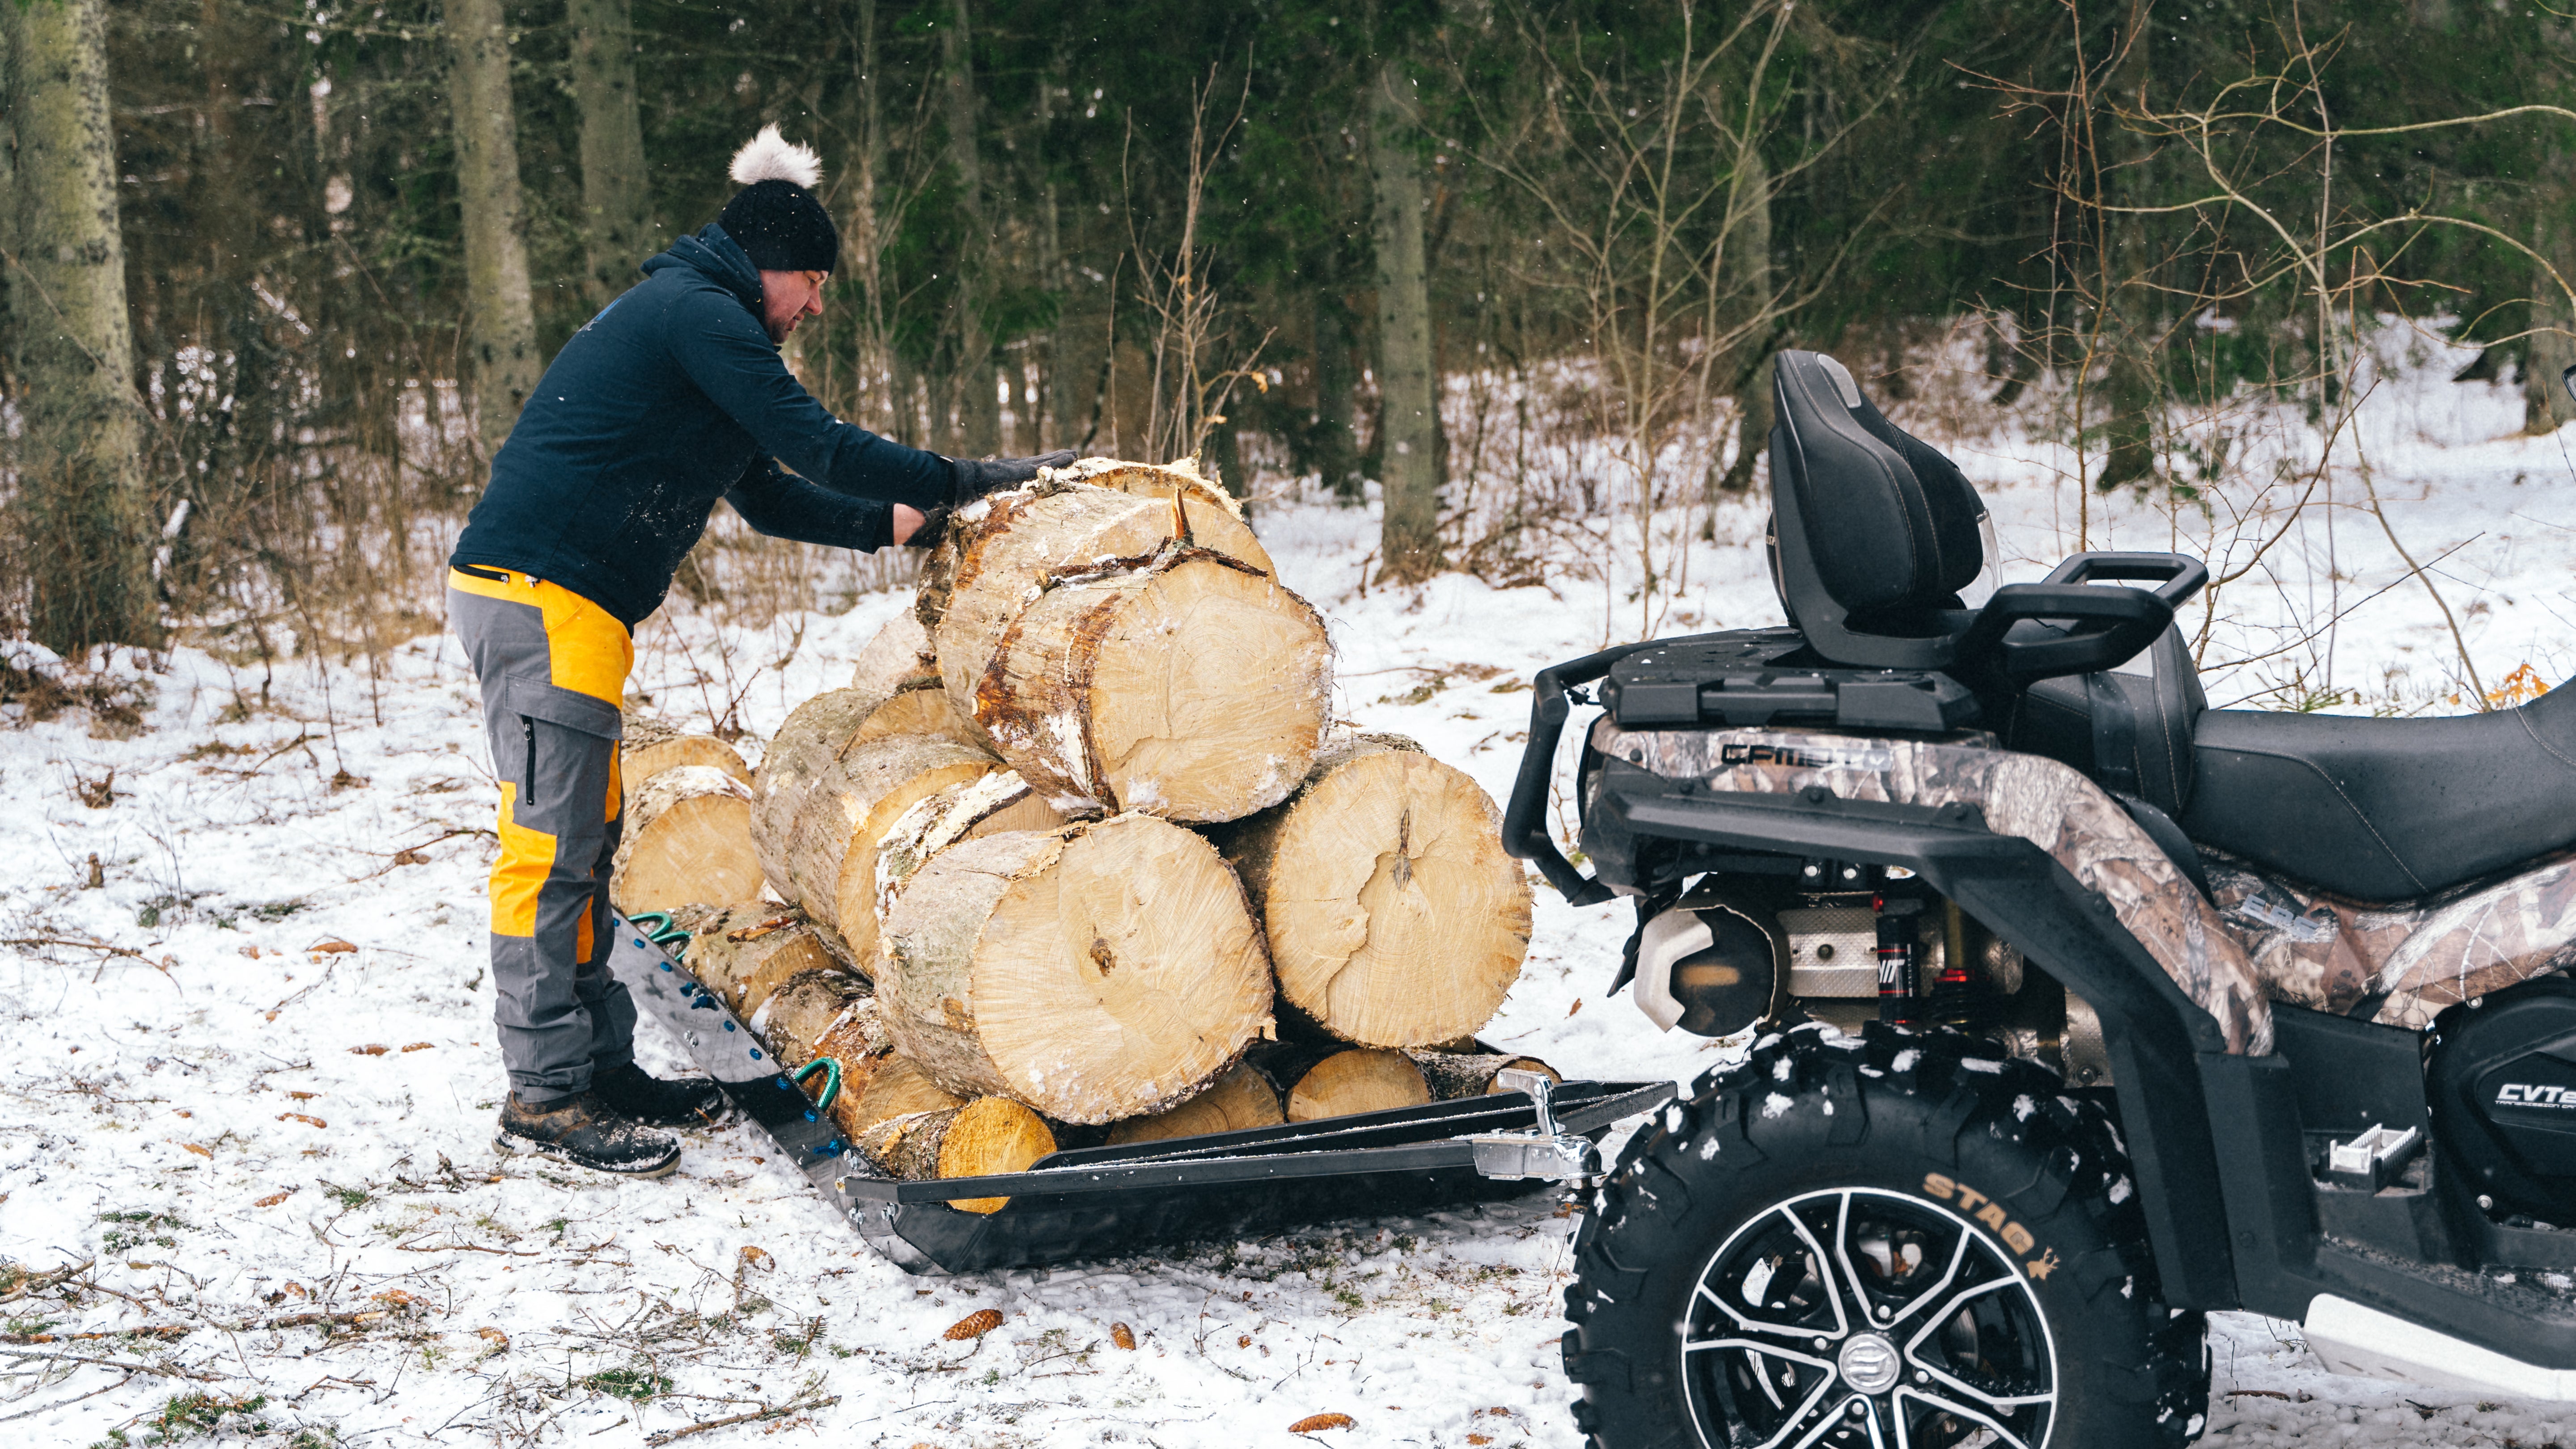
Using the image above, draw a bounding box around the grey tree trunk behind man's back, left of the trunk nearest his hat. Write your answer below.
[445,0,543,463]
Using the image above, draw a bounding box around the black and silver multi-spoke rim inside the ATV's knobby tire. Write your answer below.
[1682,1187,2058,1449]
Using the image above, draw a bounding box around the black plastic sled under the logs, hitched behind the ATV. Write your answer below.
[608,919,1674,1274]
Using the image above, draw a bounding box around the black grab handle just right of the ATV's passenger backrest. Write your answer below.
[1958,553,2210,684]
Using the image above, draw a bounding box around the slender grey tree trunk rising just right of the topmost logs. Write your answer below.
[1368,59,1440,584]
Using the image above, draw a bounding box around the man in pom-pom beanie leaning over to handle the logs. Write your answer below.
[448,126,1074,1176]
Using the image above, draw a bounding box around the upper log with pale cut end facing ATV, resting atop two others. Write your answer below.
[968,548,1332,821]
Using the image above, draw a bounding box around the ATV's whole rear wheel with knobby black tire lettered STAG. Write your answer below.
[1563,1024,2210,1449]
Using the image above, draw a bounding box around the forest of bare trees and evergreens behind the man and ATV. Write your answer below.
[0,0,2576,674]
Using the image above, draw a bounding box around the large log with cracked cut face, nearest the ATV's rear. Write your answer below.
[1208,736,1530,1048]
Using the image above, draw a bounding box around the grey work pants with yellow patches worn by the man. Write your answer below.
[448,566,636,1102]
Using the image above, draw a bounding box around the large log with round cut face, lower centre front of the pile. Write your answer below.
[878,816,1270,1125]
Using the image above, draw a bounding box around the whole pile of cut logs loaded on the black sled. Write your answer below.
[613,458,1553,1212]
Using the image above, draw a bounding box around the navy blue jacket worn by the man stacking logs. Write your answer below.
[451,227,950,628]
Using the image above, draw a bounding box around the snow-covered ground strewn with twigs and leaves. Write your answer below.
[0,345,2576,1449]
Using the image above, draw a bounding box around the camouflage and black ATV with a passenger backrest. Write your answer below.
[1504,353,2576,1449]
